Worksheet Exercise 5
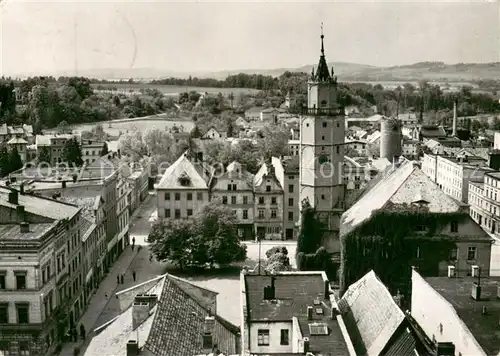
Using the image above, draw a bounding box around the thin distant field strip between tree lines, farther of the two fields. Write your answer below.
[92,83,259,95]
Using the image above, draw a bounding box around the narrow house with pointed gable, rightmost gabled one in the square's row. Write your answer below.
[253,162,283,240]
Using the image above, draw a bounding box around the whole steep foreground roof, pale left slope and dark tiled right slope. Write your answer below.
[85,274,239,356]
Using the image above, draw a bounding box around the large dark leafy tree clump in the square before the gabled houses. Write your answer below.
[148,202,246,269]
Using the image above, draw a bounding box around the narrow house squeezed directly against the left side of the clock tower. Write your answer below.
[271,156,300,240]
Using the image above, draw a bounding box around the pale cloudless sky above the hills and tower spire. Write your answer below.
[0,0,500,75]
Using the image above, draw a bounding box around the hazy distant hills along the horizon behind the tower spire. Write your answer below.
[14,62,500,82]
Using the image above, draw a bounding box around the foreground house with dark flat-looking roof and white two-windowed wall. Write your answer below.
[240,272,356,356]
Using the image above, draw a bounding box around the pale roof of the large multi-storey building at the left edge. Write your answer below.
[0,187,81,220]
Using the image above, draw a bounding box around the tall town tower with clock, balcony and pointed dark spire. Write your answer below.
[299,28,345,252]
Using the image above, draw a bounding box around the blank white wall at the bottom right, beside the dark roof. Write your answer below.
[411,271,486,356]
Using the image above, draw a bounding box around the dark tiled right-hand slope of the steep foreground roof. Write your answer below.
[145,276,239,356]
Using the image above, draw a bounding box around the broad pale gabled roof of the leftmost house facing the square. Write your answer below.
[157,151,213,190]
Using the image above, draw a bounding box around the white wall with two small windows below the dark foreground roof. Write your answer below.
[250,320,294,353]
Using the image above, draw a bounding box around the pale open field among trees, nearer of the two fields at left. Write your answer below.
[71,120,194,136]
